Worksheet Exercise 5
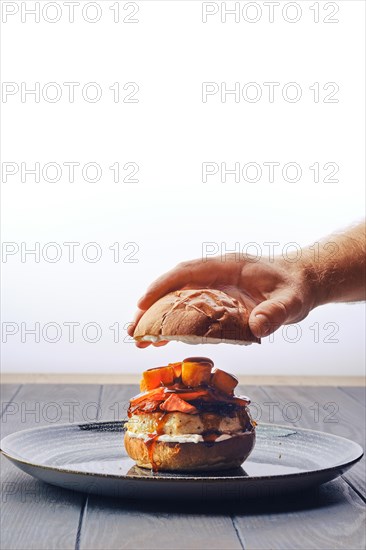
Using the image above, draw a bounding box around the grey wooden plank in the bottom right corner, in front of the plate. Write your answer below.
[234,479,366,550]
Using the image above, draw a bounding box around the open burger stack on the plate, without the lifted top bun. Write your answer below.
[124,357,255,472]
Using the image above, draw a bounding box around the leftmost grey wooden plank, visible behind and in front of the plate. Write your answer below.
[0,385,100,550]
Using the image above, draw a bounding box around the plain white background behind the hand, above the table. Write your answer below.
[2,0,365,375]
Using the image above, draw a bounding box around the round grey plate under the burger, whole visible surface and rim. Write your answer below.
[1,422,363,499]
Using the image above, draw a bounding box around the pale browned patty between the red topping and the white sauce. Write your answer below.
[125,409,251,435]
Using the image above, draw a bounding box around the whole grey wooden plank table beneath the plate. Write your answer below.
[0,383,366,550]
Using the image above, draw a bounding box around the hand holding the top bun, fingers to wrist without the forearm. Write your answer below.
[128,254,314,348]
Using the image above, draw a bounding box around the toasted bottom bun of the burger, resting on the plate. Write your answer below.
[124,430,255,472]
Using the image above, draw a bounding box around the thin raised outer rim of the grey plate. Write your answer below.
[0,420,364,483]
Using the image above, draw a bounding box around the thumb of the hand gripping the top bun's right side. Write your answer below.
[249,296,290,338]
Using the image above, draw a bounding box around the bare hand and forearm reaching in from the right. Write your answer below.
[128,223,366,347]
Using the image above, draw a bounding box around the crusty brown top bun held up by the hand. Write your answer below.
[133,288,260,345]
